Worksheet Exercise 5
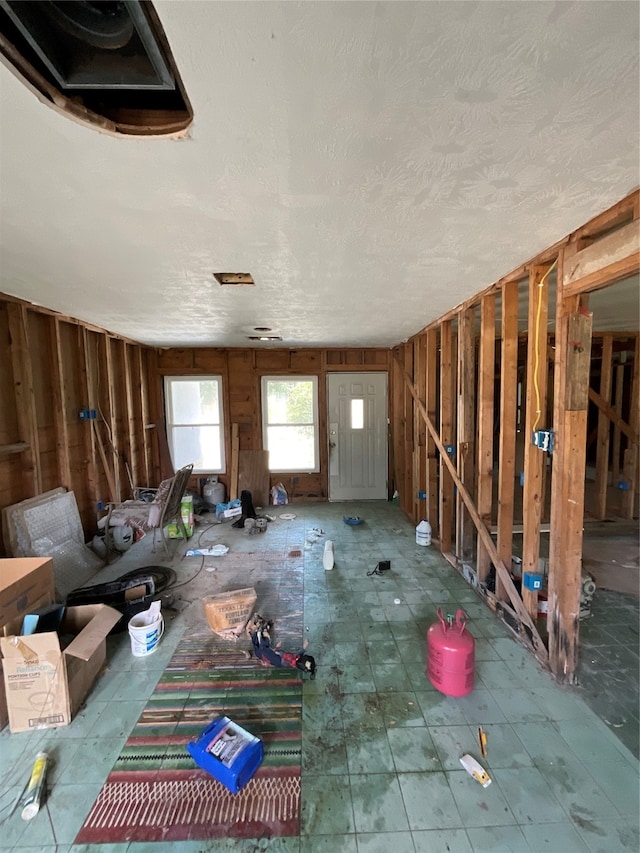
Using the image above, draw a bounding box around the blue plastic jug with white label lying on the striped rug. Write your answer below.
[187,717,264,794]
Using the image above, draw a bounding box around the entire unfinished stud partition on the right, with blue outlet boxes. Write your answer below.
[391,192,640,680]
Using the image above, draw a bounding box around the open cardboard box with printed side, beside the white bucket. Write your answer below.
[0,604,122,732]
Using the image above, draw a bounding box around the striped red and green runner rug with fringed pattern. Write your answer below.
[74,560,302,844]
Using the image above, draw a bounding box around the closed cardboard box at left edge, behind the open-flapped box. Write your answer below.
[0,557,55,730]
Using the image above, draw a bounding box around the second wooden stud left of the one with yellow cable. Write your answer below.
[476,294,496,582]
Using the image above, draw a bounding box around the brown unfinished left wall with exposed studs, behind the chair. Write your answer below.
[0,295,159,555]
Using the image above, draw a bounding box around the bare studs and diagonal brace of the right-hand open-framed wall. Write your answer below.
[392,192,640,681]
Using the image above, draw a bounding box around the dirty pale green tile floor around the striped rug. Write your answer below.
[0,502,639,853]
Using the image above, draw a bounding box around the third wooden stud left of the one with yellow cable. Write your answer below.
[456,308,476,561]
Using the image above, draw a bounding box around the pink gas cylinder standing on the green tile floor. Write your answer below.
[426,607,476,696]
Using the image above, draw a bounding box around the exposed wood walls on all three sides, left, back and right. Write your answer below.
[0,192,640,680]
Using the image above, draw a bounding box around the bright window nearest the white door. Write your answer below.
[262,376,319,472]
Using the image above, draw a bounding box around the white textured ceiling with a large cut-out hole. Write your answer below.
[0,0,640,347]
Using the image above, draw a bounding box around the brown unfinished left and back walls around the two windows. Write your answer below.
[0,288,390,555]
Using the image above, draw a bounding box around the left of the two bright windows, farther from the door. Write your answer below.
[164,376,225,474]
